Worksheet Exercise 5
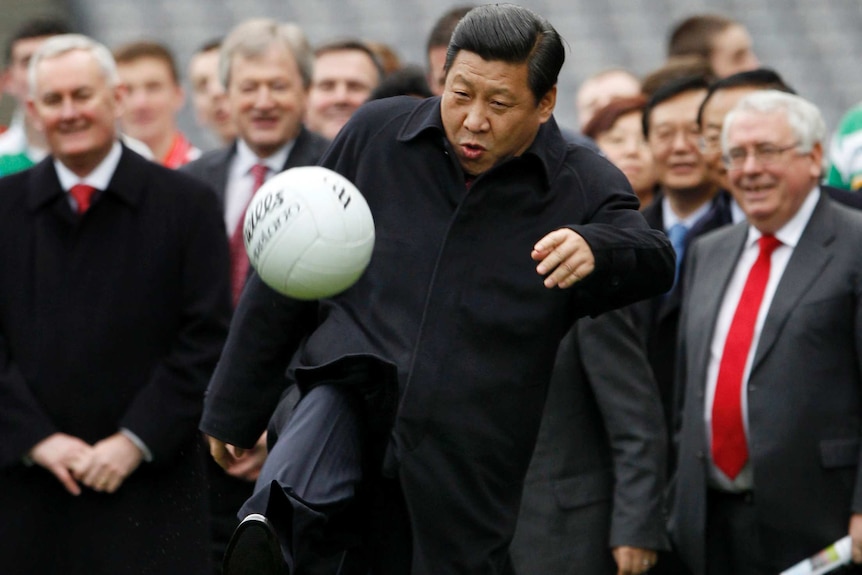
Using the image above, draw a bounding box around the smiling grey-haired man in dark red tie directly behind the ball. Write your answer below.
[183,19,329,303]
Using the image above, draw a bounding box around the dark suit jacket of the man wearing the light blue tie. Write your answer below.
[630,190,732,440]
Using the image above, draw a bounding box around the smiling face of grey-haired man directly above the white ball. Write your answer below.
[227,43,308,158]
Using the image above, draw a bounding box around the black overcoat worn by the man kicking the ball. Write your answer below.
[202,98,673,575]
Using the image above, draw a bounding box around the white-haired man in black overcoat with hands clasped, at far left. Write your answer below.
[0,35,230,575]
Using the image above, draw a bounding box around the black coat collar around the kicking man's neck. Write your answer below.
[397,96,568,186]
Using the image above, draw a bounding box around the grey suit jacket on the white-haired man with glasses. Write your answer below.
[671,194,862,575]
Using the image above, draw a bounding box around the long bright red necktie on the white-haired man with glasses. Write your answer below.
[712,235,781,479]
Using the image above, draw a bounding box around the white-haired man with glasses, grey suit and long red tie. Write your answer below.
[671,90,862,575]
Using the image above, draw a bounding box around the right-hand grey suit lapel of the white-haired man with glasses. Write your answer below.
[751,197,835,373]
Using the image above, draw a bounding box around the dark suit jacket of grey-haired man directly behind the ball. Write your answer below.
[180,128,329,216]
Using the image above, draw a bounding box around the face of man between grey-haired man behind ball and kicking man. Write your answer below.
[305,50,380,139]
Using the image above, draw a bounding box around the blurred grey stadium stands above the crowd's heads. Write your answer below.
[0,0,862,151]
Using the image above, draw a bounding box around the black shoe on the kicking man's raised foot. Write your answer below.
[222,513,290,575]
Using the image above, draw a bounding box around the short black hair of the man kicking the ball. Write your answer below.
[445,4,566,104]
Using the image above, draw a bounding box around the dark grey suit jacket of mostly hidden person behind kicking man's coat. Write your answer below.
[510,311,667,575]
